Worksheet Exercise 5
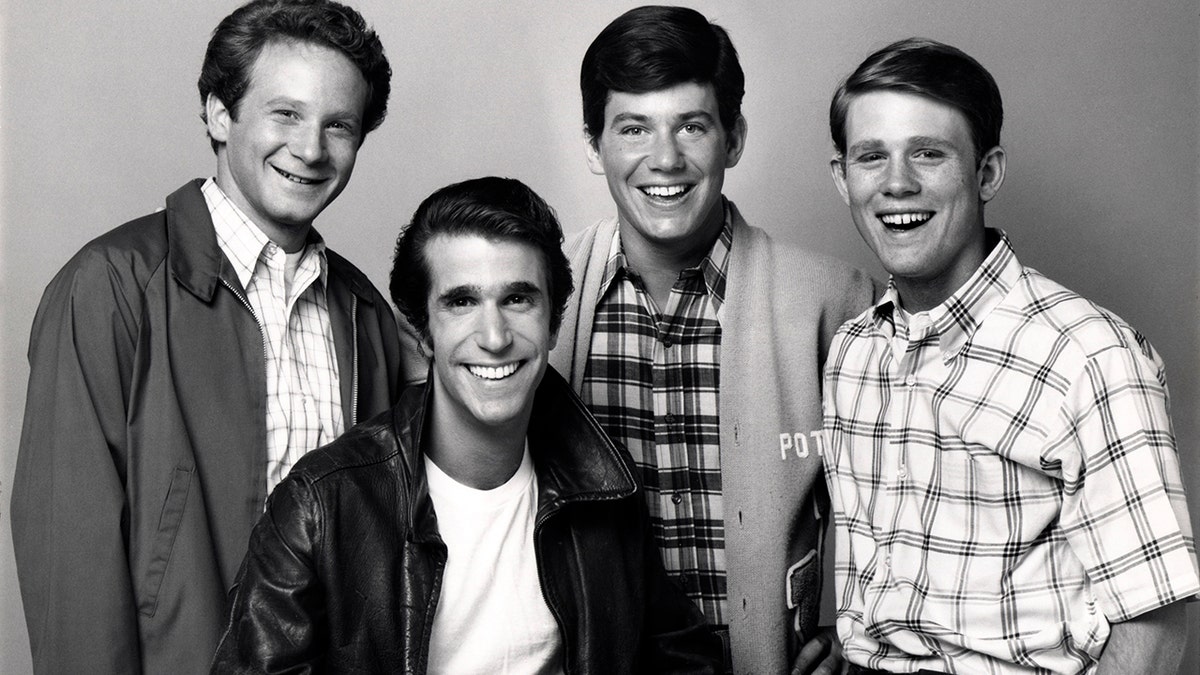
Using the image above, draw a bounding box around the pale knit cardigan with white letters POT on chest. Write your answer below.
[551,204,874,673]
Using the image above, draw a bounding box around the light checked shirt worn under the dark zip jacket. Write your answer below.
[202,178,343,494]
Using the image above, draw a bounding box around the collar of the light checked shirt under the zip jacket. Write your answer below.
[200,178,329,288]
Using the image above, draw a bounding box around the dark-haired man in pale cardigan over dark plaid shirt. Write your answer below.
[552,7,872,673]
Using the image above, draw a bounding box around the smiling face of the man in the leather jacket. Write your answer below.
[422,234,554,438]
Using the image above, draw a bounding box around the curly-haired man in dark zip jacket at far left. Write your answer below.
[12,0,400,674]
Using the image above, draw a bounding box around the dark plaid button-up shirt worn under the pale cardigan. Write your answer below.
[582,204,732,625]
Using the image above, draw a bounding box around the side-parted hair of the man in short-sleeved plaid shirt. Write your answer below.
[829,37,1004,162]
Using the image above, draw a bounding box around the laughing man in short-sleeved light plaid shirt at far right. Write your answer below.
[824,38,1200,674]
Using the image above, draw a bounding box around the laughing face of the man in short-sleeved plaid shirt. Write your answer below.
[830,90,1006,311]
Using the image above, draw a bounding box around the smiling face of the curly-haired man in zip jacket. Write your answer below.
[206,42,367,251]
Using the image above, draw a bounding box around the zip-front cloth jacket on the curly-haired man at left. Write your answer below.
[12,181,400,675]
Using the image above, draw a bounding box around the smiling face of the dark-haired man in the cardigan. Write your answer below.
[588,83,745,263]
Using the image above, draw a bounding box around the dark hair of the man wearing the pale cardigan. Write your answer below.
[580,5,745,144]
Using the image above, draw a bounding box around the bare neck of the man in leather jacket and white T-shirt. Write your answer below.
[424,393,529,490]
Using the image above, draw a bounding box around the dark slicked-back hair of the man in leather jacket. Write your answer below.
[388,175,574,339]
